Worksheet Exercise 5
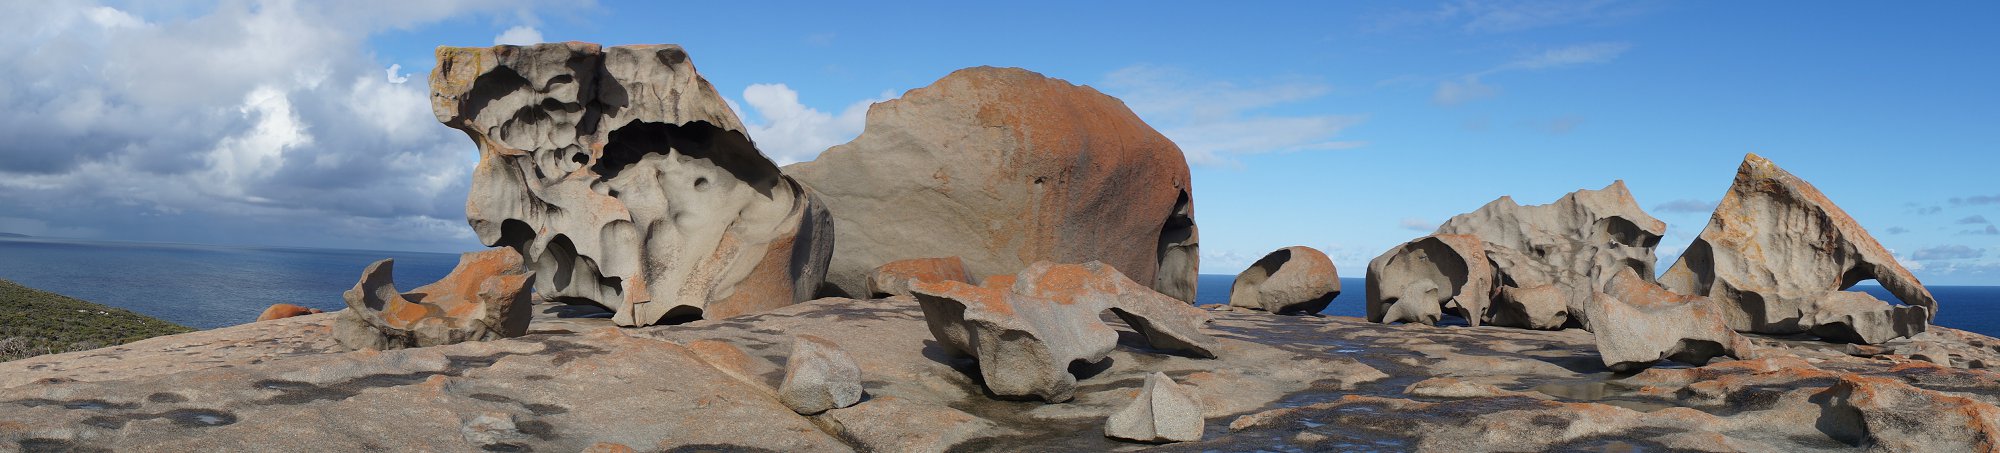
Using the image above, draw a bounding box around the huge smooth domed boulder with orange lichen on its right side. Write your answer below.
[784,66,1198,303]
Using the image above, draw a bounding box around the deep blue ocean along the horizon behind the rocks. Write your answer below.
[0,237,2000,337]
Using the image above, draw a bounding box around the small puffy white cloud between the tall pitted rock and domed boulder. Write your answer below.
[730,84,878,164]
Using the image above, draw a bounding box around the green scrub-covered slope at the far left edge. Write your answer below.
[0,281,194,361]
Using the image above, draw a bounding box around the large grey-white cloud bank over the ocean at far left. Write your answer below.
[0,0,572,249]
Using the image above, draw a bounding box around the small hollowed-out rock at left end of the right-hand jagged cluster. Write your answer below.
[1366,235,1494,325]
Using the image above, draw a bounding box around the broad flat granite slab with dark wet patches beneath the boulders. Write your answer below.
[0,299,2000,451]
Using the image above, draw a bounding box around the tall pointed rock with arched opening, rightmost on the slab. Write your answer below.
[1660,154,1938,343]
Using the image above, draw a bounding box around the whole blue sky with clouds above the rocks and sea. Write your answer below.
[0,0,2000,285]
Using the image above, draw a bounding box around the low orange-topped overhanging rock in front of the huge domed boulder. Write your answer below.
[910,263,1218,403]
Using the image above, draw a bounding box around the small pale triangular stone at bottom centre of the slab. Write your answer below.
[1104,371,1208,443]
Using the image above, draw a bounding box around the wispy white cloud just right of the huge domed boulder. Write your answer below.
[1102,66,1366,164]
